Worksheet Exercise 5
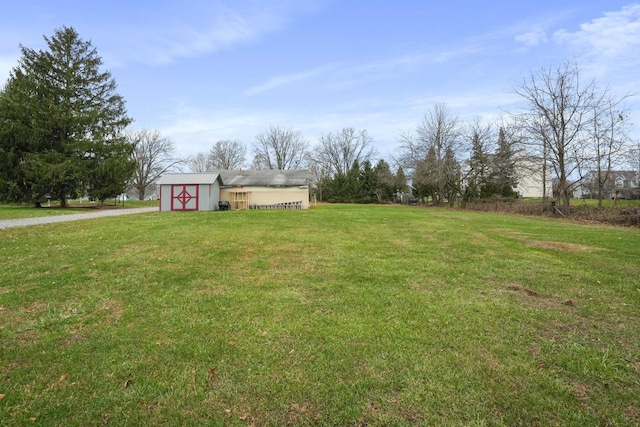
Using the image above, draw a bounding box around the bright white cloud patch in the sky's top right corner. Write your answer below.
[553,4,640,58]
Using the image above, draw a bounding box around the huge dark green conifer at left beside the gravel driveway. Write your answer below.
[0,27,133,206]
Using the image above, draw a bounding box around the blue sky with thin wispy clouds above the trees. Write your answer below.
[0,0,640,164]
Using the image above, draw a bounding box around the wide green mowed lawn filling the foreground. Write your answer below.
[0,205,640,426]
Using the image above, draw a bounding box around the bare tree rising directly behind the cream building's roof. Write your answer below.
[253,126,309,170]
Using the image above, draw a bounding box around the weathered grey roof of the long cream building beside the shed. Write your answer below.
[215,169,309,187]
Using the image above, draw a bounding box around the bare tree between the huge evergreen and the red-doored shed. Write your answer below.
[127,129,186,200]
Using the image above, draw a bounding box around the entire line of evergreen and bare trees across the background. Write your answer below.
[0,27,640,209]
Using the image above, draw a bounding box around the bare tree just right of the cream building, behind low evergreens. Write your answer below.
[313,128,375,175]
